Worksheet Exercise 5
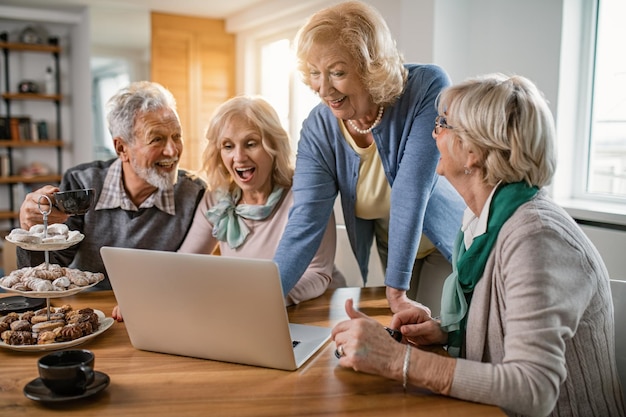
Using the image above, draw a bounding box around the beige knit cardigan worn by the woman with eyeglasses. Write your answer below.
[451,190,625,416]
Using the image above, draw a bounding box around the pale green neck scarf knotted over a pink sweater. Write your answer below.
[206,186,284,249]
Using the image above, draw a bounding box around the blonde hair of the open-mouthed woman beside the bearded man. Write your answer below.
[202,96,294,190]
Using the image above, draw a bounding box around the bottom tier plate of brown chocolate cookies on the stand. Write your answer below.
[0,305,115,352]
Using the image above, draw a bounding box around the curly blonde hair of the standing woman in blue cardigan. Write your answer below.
[296,1,408,105]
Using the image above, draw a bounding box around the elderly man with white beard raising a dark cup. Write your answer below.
[17,81,205,289]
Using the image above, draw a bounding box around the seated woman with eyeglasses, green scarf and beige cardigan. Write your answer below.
[332,74,625,416]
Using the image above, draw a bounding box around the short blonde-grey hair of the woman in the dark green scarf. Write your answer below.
[437,74,556,187]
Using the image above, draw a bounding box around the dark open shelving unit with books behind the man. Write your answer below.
[0,39,63,227]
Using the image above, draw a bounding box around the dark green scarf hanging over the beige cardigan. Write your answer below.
[441,182,539,356]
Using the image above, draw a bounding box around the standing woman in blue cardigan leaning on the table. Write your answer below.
[274,1,465,313]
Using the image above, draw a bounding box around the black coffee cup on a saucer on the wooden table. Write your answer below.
[37,349,95,396]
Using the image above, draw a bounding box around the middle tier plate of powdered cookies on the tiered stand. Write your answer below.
[0,263,104,298]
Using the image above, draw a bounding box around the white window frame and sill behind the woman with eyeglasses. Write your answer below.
[550,0,626,224]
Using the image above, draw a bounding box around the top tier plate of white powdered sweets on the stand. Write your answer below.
[5,223,85,251]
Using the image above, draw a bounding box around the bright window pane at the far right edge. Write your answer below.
[583,0,626,201]
